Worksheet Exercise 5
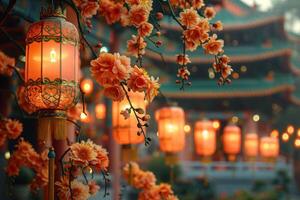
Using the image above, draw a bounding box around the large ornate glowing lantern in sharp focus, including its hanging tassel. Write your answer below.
[25,9,79,139]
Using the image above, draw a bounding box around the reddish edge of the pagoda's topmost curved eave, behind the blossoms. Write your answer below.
[161,16,284,31]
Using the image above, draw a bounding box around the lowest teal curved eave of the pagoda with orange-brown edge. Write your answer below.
[161,76,295,99]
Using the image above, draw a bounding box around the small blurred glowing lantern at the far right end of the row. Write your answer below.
[259,137,279,159]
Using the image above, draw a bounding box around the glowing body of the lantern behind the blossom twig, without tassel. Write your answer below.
[112,92,146,145]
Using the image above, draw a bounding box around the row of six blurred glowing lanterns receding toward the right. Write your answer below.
[112,92,279,160]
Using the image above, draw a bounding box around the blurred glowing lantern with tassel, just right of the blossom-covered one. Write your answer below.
[155,106,185,165]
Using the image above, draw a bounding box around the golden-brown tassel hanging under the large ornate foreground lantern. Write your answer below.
[38,117,67,141]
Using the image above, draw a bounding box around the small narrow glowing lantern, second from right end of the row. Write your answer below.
[244,133,258,158]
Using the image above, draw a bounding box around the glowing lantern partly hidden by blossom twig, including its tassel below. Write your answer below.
[112,91,146,163]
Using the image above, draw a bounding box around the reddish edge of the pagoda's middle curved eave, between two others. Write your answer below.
[146,48,293,64]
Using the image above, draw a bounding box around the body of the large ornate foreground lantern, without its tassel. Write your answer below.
[25,7,80,114]
